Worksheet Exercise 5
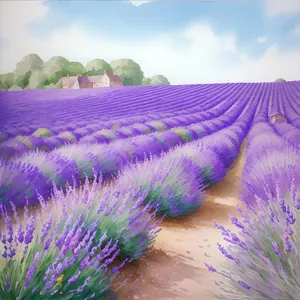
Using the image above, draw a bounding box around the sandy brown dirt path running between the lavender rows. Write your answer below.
[112,144,245,300]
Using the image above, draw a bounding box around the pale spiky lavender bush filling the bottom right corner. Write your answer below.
[206,177,300,300]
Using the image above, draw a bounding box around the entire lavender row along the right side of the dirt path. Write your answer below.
[206,116,300,300]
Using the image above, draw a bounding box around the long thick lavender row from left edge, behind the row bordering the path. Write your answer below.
[0,95,251,210]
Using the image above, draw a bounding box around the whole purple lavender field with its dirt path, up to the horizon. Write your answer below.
[0,81,300,300]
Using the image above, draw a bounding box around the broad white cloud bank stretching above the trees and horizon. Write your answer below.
[0,1,300,84]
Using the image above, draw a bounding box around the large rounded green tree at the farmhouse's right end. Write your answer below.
[110,58,144,85]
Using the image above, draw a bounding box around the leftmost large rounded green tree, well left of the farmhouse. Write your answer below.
[13,54,44,89]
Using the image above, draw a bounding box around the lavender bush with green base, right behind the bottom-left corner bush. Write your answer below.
[52,174,162,259]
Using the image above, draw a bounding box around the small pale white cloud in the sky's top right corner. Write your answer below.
[265,0,300,17]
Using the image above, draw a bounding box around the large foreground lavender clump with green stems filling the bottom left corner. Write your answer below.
[0,172,161,299]
